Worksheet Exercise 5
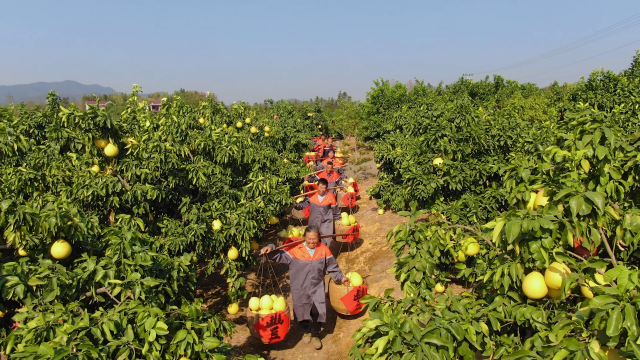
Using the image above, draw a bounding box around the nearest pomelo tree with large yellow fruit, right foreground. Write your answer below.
[350,53,640,360]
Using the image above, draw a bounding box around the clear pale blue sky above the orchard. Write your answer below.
[0,0,640,103]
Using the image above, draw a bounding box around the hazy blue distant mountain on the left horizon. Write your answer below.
[0,80,116,105]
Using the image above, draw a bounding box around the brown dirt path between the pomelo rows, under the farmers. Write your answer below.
[199,141,406,360]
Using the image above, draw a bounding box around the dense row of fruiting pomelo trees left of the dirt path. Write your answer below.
[0,86,317,359]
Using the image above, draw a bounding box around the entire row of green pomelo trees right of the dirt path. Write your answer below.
[350,50,640,360]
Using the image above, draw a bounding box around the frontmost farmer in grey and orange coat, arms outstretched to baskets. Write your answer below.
[260,225,349,350]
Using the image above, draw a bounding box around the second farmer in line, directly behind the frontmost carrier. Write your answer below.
[293,178,340,247]
